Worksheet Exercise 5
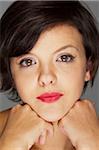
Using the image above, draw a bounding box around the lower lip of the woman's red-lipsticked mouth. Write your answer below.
[37,95,63,103]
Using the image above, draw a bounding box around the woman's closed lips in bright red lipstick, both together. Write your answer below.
[36,92,63,103]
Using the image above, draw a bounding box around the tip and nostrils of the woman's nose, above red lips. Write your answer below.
[38,67,56,87]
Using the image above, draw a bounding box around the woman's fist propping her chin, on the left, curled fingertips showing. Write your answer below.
[0,104,53,150]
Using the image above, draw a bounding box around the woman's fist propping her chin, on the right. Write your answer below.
[59,100,99,150]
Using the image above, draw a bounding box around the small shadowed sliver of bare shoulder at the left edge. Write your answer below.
[0,109,10,135]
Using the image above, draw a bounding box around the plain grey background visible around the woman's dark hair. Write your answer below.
[0,1,99,114]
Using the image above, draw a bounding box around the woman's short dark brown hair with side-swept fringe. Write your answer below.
[0,0,99,101]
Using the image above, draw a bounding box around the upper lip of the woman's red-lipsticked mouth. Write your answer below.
[37,92,63,99]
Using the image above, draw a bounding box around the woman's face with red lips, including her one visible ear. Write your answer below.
[11,25,90,122]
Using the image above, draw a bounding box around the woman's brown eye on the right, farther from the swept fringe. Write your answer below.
[56,54,75,63]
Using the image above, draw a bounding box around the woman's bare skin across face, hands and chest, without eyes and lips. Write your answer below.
[0,25,99,150]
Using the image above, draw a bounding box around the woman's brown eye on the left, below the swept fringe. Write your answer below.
[20,58,36,67]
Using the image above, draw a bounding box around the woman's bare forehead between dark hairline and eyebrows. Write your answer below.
[31,25,84,53]
